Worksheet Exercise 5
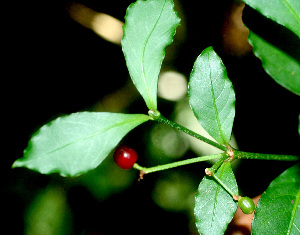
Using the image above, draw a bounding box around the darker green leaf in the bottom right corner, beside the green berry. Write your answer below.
[251,164,300,235]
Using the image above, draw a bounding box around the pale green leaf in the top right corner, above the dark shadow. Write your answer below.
[244,0,300,37]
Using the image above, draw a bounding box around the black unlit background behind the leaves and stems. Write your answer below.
[2,0,300,234]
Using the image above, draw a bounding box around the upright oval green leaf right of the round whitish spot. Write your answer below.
[189,47,235,145]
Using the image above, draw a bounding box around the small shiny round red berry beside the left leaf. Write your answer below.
[114,145,138,170]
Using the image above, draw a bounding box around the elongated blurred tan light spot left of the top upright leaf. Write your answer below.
[69,3,124,44]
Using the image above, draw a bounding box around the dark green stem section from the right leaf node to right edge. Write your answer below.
[233,149,300,161]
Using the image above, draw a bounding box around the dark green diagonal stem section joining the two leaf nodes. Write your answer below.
[148,110,228,152]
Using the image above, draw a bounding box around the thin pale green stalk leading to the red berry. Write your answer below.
[133,154,222,174]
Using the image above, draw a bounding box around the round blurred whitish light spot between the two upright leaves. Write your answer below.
[158,71,188,101]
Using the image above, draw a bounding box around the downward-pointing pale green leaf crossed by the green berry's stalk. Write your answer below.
[194,162,238,235]
